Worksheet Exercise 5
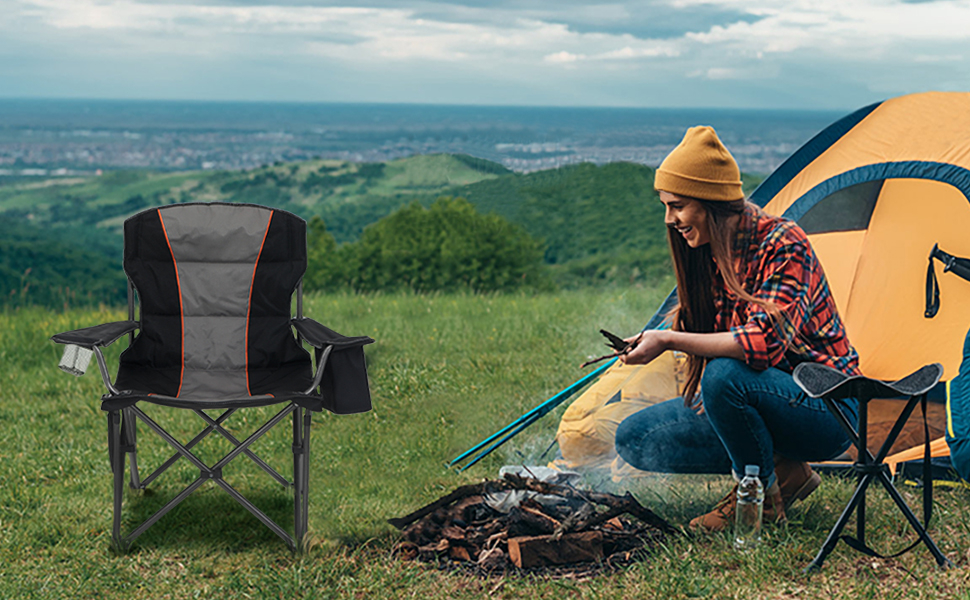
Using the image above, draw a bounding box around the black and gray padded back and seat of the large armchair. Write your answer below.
[117,204,311,398]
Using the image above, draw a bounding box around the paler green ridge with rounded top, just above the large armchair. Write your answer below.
[0,154,500,236]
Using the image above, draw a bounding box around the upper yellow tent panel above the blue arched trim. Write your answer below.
[765,92,970,215]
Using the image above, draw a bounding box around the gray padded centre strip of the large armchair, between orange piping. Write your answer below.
[159,205,272,397]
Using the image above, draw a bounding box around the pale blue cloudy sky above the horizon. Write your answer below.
[0,0,970,110]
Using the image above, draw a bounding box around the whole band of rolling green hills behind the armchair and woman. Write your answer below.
[0,154,757,303]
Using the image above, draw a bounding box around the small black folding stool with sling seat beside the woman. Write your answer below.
[793,363,951,571]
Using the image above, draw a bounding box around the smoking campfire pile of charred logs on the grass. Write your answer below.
[389,473,676,574]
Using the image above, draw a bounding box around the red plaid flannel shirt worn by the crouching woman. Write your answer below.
[714,205,860,375]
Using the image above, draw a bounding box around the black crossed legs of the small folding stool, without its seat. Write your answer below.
[805,392,952,572]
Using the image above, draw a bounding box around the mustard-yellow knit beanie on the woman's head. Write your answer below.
[653,126,744,201]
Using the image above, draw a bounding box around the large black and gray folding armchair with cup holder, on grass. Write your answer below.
[51,204,374,551]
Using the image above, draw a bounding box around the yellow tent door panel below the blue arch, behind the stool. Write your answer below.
[840,179,970,380]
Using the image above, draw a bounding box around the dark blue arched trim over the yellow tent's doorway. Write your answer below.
[780,160,970,222]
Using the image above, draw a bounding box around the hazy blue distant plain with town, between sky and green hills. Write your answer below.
[0,99,858,176]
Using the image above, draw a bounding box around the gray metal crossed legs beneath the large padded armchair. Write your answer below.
[107,402,311,552]
